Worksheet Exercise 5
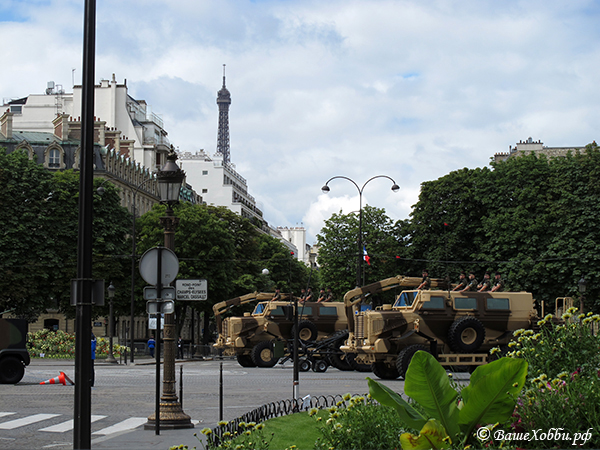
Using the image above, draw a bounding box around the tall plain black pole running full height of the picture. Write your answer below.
[73,0,96,450]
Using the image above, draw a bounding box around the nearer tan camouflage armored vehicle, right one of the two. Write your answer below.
[341,276,537,379]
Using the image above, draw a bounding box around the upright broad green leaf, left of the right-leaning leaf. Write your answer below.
[404,350,460,438]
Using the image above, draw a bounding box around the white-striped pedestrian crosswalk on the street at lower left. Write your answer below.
[0,411,148,436]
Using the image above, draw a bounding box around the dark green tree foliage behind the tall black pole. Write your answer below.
[0,150,130,321]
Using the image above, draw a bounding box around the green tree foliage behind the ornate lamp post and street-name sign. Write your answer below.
[137,203,309,338]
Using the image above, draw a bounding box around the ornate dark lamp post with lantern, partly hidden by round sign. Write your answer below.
[145,149,194,432]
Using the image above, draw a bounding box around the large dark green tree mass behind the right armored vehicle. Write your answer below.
[317,143,600,311]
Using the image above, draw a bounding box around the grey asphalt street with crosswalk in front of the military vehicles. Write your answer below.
[0,359,418,449]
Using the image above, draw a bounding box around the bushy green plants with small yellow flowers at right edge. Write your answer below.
[508,308,600,448]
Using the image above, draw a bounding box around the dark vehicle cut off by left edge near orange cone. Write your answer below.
[0,319,31,384]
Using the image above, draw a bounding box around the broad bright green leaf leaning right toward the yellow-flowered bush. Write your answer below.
[459,358,527,435]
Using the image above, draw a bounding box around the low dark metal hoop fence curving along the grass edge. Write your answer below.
[207,394,356,445]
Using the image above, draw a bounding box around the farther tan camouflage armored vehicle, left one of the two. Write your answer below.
[213,292,348,370]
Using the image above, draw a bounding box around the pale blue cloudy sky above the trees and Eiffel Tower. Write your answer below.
[0,0,600,242]
